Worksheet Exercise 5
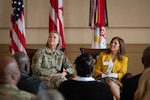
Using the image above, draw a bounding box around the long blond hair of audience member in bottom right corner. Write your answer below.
[134,68,150,100]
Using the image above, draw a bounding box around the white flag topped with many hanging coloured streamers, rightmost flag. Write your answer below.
[89,0,108,49]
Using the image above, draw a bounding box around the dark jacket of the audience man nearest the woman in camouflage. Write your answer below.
[17,73,48,94]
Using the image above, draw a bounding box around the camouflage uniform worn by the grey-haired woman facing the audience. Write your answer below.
[31,47,74,87]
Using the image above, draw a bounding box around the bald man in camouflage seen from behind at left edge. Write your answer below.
[0,56,34,100]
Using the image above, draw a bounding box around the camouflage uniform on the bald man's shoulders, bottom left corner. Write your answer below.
[0,84,35,100]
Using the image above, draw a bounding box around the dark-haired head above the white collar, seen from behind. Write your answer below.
[75,54,94,77]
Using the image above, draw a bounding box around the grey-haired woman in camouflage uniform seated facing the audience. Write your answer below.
[31,31,74,88]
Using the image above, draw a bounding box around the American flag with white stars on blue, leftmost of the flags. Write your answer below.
[9,0,26,55]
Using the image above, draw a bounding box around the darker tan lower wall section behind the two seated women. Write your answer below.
[0,44,150,75]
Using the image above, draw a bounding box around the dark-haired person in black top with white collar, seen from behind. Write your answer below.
[58,54,113,100]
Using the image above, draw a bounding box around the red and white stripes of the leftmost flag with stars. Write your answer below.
[9,1,26,55]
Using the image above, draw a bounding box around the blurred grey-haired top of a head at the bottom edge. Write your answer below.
[33,89,64,100]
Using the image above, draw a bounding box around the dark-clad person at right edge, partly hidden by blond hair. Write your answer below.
[121,47,150,100]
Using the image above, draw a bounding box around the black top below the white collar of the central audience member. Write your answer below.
[58,80,113,100]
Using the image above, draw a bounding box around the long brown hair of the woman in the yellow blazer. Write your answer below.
[110,37,125,60]
